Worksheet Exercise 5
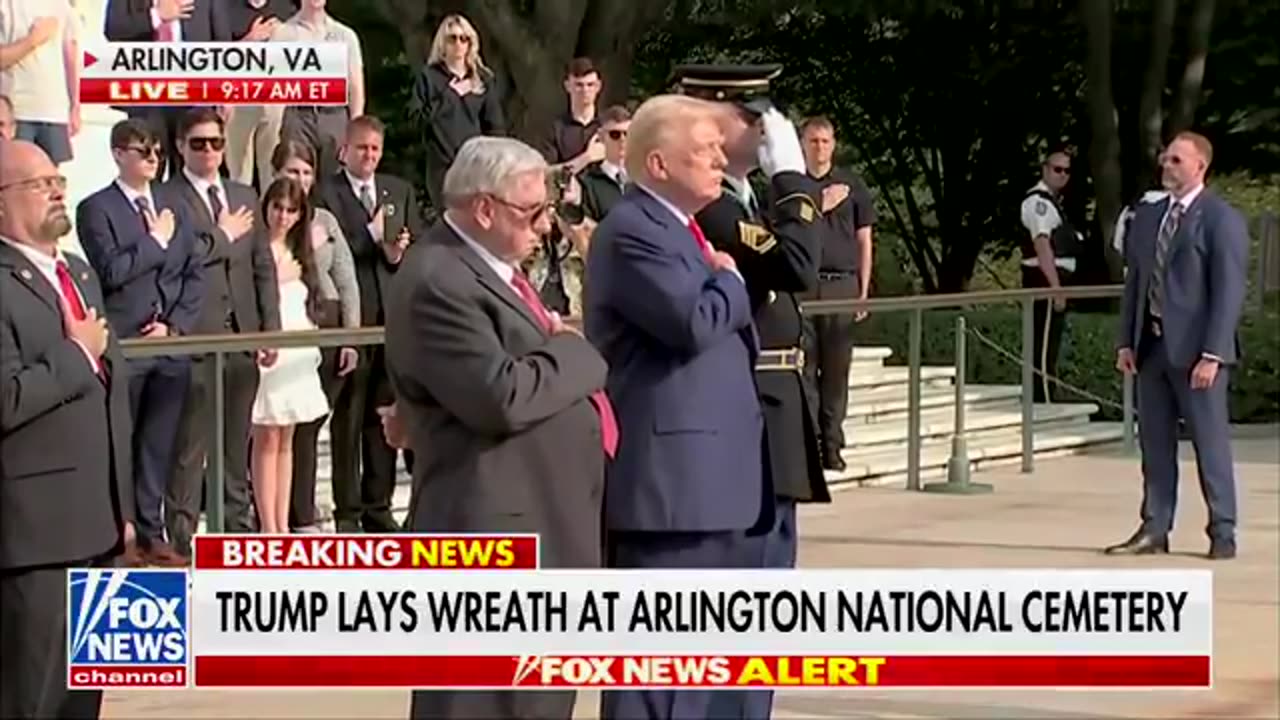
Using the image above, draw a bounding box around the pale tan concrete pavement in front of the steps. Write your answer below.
[104,427,1280,720]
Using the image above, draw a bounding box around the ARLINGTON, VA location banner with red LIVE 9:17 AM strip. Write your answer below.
[79,42,351,106]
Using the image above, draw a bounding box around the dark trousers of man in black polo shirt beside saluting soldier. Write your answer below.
[804,273,859,457]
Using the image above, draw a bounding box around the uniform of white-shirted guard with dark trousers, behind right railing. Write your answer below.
[1021,181,1082,402]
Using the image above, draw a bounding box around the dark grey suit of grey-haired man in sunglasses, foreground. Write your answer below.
[387,222,605,719]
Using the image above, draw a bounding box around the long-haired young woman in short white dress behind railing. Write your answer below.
[251,178,329,533]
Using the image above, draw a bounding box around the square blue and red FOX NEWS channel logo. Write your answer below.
[67,569,189,689]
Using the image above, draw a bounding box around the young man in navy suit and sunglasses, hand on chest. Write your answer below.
[76,118,205,568]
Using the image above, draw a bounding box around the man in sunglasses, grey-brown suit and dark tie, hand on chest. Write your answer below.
[165,108,280,545]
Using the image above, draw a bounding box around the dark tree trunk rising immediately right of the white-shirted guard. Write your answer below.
[1080,0,1124,278]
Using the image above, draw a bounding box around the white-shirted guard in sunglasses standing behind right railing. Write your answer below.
[1020,150,1082,402]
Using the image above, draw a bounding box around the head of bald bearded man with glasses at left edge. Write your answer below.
[0,140,72,251]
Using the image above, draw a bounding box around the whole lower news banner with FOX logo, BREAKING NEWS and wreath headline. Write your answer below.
[68,536,1213,689]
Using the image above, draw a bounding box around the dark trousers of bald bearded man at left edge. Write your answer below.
[0,560,108,719]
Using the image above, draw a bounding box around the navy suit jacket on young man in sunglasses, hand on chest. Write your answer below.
[76,182,205,337]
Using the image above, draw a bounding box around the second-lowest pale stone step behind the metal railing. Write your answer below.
[845,400,1098,451]
